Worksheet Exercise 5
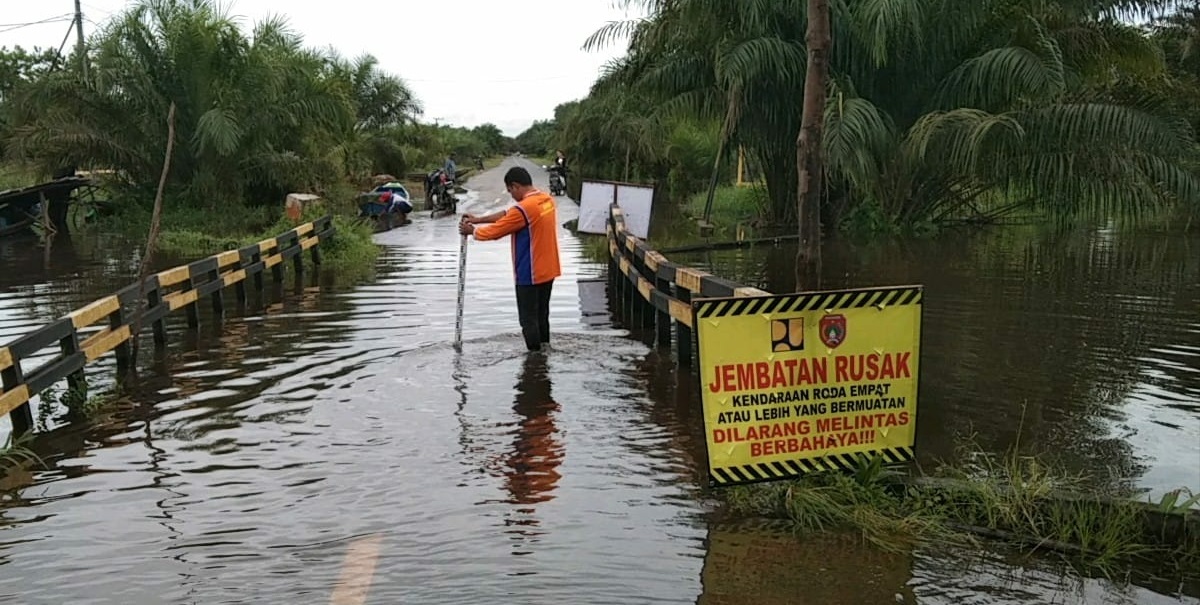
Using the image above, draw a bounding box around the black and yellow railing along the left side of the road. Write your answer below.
[0,216,334,435]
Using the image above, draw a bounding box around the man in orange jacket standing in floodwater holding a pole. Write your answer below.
[458,166,563,351]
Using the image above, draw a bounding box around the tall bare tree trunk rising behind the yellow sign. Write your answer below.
[796,0,833,289]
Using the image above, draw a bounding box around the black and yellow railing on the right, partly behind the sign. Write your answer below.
[605,204,770,367]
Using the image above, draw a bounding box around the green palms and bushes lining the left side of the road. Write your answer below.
[0,0,514,265]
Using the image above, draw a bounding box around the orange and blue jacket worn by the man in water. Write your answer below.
[475,191,563,286]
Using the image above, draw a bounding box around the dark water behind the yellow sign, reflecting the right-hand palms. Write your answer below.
[677,229,1200,498]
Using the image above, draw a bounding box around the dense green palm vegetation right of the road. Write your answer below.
[516,0,1200,243]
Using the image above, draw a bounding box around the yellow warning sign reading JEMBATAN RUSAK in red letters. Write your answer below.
[692,286,923,485]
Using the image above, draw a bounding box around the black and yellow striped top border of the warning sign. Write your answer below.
[692,286,924,319]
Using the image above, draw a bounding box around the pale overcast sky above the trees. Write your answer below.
[0,0,641,136]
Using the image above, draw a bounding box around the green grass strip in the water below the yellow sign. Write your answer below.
[725,434,1200,580]
